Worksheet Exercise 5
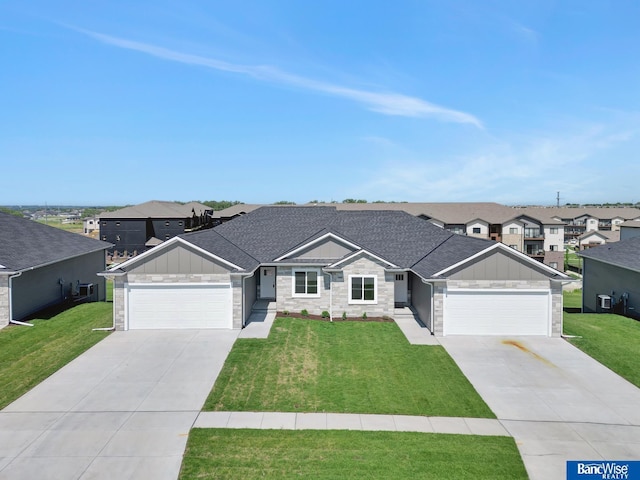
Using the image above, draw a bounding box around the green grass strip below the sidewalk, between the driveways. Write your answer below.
[180,428,527,480]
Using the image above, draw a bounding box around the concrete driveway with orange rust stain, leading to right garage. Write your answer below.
[439,337,640,480]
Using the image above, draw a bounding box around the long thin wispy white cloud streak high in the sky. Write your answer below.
[74,29,482,128]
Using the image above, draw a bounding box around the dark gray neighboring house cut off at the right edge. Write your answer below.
[578,236,640,318]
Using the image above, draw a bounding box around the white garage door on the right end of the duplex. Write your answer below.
[444,290,551,335]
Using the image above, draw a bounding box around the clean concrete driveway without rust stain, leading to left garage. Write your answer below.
[0,330,239,480]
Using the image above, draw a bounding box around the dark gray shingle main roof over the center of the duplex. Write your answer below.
[182,206,494,278]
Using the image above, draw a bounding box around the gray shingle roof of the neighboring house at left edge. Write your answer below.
[0,212,111,273]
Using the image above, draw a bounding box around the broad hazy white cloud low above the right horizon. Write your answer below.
[352,126,640,204]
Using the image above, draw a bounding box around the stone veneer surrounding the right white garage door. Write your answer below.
[433,280,562,337]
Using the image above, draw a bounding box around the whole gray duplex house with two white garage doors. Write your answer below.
[104,206,569,336]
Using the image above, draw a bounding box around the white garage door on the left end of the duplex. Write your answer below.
[127,284,233,330]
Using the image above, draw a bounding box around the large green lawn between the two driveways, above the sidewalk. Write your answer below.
[204,318,495,418]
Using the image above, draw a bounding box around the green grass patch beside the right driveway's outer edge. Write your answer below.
[564,313,640,387]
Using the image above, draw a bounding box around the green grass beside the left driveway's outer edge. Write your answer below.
[0,302,112,409]
